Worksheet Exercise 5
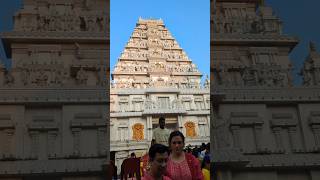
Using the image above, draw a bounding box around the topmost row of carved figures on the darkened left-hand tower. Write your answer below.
[15,4,107,32]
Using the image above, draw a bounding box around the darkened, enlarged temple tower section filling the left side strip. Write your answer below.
[0,0,109,180]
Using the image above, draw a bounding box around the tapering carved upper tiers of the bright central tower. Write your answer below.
[113,19,201,88]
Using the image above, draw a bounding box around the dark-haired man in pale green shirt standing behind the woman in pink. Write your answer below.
[151,117,171,146]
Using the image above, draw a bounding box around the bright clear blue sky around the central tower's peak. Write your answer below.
[110,0,210,80]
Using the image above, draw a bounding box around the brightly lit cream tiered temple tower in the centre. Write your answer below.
[110,18,210,172]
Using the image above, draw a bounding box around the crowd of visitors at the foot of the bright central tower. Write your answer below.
[114,117,211,180]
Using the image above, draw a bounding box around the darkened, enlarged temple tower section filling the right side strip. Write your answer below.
[210,0,320,180]
